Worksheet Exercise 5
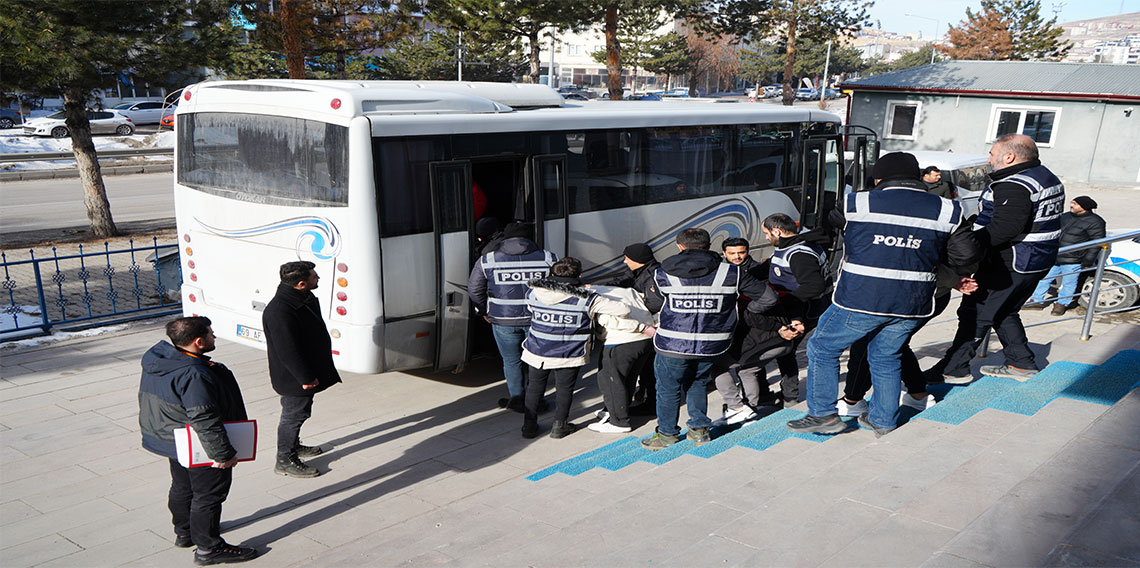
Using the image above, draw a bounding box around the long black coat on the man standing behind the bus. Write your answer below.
[261,284,341,397]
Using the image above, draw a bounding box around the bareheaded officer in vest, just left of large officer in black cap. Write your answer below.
[760,213,832,406]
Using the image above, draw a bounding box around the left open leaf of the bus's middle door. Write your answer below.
[430,161,474,371]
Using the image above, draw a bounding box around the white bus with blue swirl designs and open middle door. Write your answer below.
[168,80,842,373]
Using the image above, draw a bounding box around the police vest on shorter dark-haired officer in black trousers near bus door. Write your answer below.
[522,291,597,358]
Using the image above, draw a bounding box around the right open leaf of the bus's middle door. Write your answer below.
[527,154,570,258]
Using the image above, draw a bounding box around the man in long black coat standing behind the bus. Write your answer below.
[261,260,341,477]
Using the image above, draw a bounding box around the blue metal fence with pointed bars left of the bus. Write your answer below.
[0,237,182,342]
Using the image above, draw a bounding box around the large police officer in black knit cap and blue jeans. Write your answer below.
[788,152,968,436]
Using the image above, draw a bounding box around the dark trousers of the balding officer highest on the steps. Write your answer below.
[938,270,1045,376]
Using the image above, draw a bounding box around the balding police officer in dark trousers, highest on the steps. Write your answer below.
[927,135,1065,384]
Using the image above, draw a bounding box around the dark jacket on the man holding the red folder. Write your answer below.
[139,341,246,462]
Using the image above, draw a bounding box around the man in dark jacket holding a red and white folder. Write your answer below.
[139,316,258,566]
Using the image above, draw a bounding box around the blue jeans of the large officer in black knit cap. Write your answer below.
[807,305,926,429]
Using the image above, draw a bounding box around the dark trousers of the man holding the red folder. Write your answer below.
[168,459,234,550]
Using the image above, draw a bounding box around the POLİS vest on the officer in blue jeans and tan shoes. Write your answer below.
[653,262,740,357]
